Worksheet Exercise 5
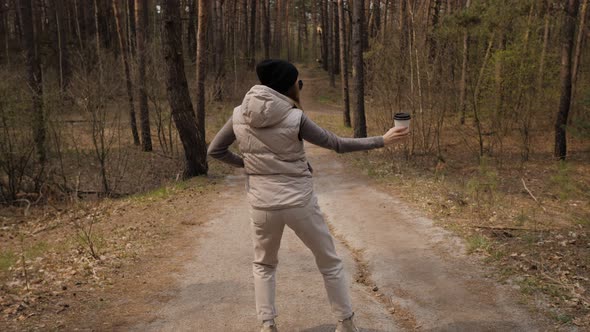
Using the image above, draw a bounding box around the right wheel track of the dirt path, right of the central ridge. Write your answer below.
[308,142,539,331]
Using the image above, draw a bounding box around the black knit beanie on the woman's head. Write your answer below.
[256,59,299,94]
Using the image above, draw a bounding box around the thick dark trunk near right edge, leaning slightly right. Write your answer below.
[554,0,579,160]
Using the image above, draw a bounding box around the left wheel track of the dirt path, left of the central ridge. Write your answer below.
[128,176,397,331]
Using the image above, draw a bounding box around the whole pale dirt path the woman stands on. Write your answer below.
[123,68,542,331]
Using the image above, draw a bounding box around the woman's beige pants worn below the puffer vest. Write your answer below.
[250,195,352,320]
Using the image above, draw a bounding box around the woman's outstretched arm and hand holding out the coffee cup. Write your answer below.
[299,114,407,153]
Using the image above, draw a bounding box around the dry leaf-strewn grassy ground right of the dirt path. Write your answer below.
[311,74,590,327]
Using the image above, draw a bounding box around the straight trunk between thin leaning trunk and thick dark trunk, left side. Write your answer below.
[135,0,152,151]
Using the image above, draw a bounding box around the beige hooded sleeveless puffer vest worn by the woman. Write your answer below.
[232,85,313,210]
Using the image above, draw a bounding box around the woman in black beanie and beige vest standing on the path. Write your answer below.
[208,60,409,332]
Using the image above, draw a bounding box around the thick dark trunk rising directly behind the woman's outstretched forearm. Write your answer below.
[352,0,367,137]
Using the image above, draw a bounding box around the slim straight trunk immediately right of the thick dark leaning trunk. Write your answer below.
[196,0,209,173]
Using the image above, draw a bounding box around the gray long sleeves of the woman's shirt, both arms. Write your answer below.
[207,114,384,167]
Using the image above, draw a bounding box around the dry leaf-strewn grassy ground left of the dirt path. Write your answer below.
[0,92,240,331]
